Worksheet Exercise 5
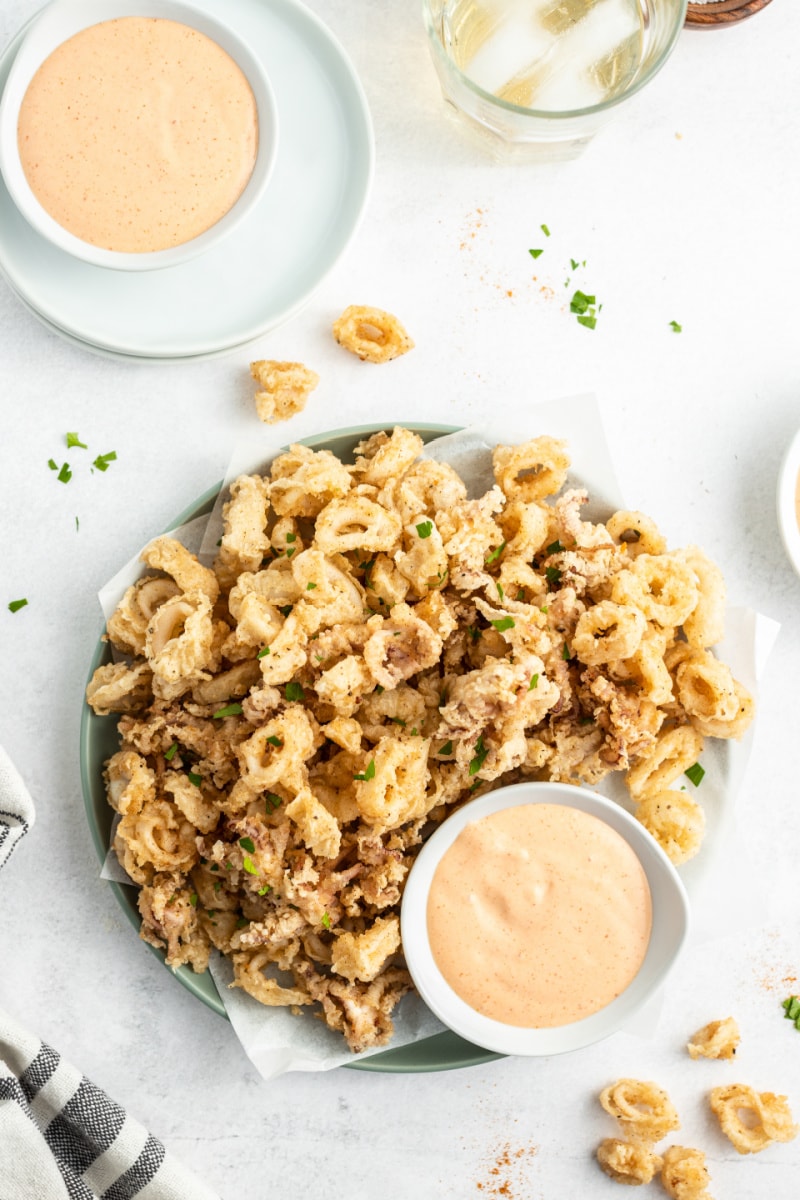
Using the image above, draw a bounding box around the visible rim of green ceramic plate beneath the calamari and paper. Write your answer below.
[80,425,501,1073]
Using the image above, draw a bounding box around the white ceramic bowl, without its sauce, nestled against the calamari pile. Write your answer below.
[401,784,688,1056]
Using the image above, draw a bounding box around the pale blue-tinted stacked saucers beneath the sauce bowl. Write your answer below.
[0,0,373,360]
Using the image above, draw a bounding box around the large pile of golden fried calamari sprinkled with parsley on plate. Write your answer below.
[88,428,752,1050]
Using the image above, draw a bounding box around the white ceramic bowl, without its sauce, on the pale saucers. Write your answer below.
[0,0,278,271]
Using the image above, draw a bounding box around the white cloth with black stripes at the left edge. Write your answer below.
[0,746,219,1200]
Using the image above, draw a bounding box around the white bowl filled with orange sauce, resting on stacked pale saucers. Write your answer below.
[0,0,278,271]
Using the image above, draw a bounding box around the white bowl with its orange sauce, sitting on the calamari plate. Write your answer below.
[401,784,688,1055]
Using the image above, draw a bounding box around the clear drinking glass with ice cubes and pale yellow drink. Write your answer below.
[422,0,686,161]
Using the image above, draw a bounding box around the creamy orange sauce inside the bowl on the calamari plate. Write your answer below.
[427,804,652,1028]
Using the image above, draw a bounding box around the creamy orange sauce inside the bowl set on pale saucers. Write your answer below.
[18,17,258,253]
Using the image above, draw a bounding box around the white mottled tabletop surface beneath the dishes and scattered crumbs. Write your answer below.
[0,0,800,1200]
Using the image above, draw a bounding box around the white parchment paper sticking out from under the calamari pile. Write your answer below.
[94,396,778,1079]
